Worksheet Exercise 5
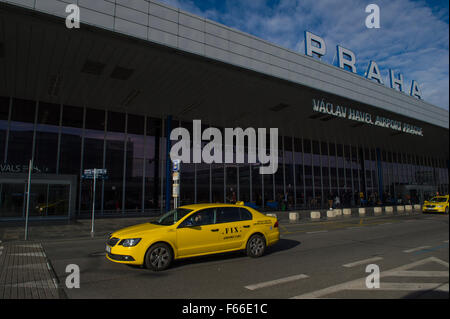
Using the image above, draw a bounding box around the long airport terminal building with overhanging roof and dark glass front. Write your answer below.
[0,0,449,221]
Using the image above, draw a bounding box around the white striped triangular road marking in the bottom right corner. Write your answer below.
[290,257,448,299]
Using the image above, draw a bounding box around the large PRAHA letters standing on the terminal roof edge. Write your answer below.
[305,31,422,99]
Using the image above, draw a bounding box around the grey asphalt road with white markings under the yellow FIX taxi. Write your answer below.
[42,215,449,299]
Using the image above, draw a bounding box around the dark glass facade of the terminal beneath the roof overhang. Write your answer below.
[0,97,449,219]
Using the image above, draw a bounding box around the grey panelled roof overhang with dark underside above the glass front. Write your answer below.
[0,0,448,157]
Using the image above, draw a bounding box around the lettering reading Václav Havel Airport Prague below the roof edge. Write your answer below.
[312,99,423,136]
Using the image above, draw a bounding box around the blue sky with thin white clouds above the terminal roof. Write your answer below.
[161,0,449,110]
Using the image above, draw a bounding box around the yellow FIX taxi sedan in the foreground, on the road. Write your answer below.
[106,202,280,271]
